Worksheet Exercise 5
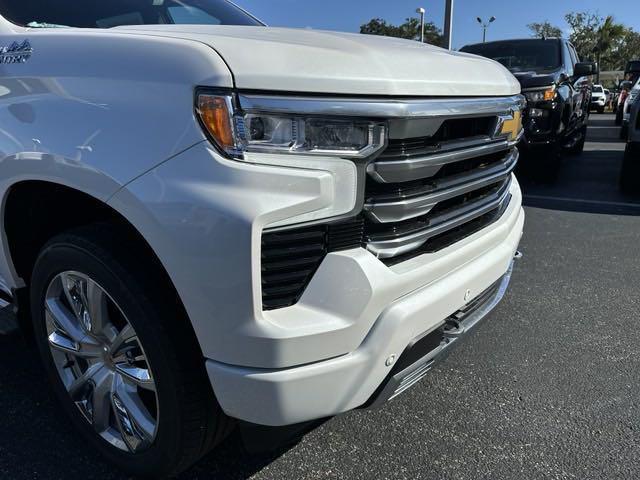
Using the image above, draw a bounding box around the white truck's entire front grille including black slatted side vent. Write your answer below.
[262,95,519,310]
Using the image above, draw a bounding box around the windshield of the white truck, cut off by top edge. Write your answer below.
[0,0,262,28]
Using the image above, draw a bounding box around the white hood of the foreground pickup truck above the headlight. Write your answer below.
[117,25,520,97]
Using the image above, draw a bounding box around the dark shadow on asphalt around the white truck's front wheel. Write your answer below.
[0,311,286,480]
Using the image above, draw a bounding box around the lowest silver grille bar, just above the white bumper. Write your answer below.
[367,180,512,259]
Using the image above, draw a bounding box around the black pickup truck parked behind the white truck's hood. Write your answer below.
[461,38,597,166]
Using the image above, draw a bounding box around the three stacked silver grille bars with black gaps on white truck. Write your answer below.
[364,137,518,264]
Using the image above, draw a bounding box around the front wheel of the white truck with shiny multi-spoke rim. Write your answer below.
[31,226,231,477]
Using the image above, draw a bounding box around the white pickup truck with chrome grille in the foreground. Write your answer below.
[0,0,524,476]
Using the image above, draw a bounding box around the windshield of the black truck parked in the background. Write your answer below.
[461,39,562,72]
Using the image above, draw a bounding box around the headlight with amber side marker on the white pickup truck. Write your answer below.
[197,93,386,158]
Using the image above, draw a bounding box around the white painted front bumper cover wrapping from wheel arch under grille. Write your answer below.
[110,139,524,425]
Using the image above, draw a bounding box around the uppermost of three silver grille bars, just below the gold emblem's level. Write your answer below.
[367,140,509,183]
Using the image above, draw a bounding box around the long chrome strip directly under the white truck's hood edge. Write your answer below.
[238,93,526,118]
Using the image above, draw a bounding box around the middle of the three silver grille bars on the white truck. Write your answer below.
[364,150,519,223]
